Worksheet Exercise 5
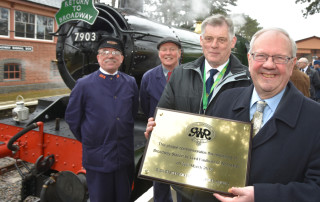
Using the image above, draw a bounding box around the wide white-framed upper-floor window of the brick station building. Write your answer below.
[15,11,54,40]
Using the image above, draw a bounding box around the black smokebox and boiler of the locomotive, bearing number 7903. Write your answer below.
[57,4,202,89]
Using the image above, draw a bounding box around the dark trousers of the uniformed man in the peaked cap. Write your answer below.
[86,166,134,202]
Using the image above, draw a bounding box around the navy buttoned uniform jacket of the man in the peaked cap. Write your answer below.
[65,70,139,173]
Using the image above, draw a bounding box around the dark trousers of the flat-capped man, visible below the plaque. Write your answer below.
[153,181,172,202]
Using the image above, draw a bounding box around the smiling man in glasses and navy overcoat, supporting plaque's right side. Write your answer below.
[209,28,320,202]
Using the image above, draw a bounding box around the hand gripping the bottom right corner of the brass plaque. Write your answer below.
[213,186,254,202]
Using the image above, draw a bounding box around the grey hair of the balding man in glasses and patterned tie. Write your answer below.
[249,27,297,57]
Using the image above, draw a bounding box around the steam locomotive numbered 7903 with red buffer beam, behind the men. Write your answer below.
[0,4,248,202]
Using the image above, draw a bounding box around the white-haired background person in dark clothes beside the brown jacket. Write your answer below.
[297,58,320,100]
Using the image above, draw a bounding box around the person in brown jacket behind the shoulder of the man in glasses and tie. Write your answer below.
[290,65,310,97]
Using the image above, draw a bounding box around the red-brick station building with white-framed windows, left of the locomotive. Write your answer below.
[0,0,66,93]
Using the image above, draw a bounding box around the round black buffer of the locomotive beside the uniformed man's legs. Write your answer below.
[41,171,86,202]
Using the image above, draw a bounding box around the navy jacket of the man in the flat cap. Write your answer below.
[140,65,167,117]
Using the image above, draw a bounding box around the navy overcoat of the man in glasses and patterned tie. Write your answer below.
[208,82,320,202]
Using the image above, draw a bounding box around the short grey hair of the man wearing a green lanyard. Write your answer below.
[201,14,235,39]
